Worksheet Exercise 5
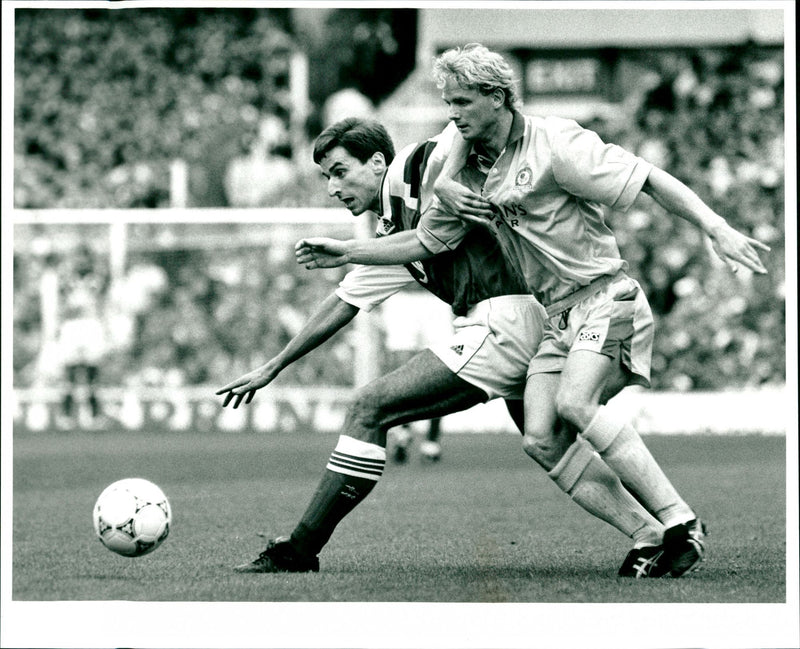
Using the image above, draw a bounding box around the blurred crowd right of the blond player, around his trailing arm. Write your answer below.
[600,45,786,390]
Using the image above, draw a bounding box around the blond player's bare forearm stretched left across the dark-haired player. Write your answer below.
[295,230,433,269]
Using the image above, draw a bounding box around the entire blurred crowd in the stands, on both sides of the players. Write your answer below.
[14,10,785,390]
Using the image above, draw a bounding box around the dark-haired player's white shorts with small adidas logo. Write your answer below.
[428,295,547,399]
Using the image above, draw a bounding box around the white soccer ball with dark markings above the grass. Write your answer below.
[93,478,172,557]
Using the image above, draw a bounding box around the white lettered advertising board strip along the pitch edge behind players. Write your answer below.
[13,386,796,435]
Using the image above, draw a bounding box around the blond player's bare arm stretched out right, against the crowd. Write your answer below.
[642,167,770,274]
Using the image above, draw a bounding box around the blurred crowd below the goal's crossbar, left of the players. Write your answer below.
[14,226,356,387]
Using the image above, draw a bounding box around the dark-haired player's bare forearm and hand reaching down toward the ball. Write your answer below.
[215,294,359,408]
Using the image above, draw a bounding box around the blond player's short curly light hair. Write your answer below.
[433,43,522,110]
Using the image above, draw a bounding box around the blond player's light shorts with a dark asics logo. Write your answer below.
[528,274,653,387]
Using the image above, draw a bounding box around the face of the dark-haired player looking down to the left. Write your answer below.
[319,146,386,216]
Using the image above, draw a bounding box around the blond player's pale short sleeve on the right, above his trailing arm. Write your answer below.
[551,120,653,211]
